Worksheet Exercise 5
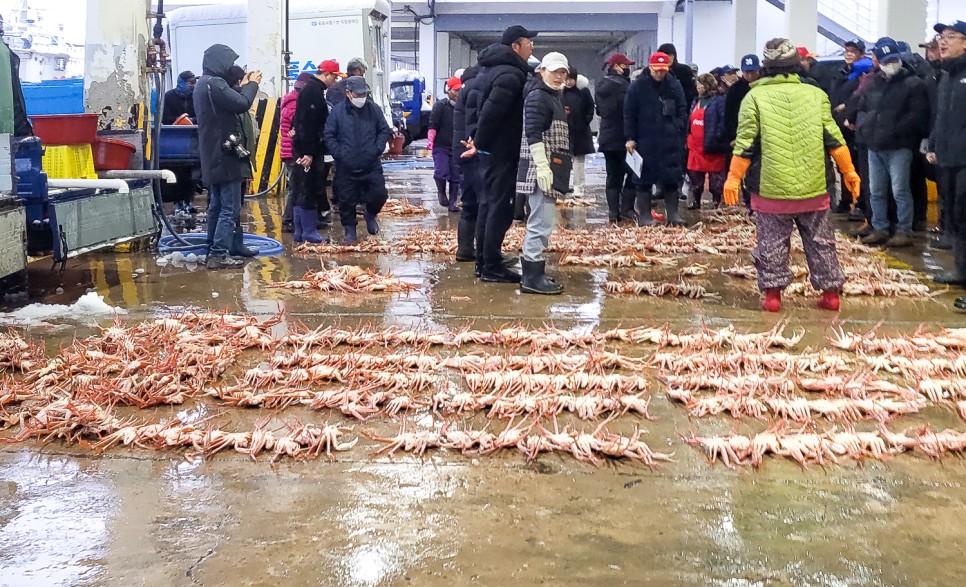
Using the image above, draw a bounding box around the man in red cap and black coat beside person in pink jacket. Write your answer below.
[292,60,339,243]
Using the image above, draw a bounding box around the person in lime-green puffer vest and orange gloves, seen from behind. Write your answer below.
[724,39,861,312]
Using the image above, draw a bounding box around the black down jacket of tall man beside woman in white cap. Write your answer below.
[473,45,530,160]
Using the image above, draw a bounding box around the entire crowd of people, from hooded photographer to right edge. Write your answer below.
[193,22,966,311]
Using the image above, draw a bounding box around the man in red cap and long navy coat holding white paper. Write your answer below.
[624,52,688,226]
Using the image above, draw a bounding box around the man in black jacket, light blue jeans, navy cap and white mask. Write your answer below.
[855,37,929,248]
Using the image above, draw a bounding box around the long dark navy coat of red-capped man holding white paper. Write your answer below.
[624,72,688,185]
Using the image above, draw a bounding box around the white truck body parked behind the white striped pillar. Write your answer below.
[168,0,392,117]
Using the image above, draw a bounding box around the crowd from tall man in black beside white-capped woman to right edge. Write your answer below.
[436,22,966,311]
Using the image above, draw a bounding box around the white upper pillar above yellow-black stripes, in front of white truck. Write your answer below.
[248,0,282,98]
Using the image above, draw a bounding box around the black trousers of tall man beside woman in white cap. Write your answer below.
[476,155,520,270]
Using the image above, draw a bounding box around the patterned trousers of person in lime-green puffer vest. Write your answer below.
[754,210,845,291]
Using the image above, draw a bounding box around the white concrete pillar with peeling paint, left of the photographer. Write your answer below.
[84,0,151,129]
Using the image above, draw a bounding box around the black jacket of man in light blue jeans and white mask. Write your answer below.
[855,68,930,152]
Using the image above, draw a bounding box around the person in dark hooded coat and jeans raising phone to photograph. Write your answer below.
[194,45,262,269]
